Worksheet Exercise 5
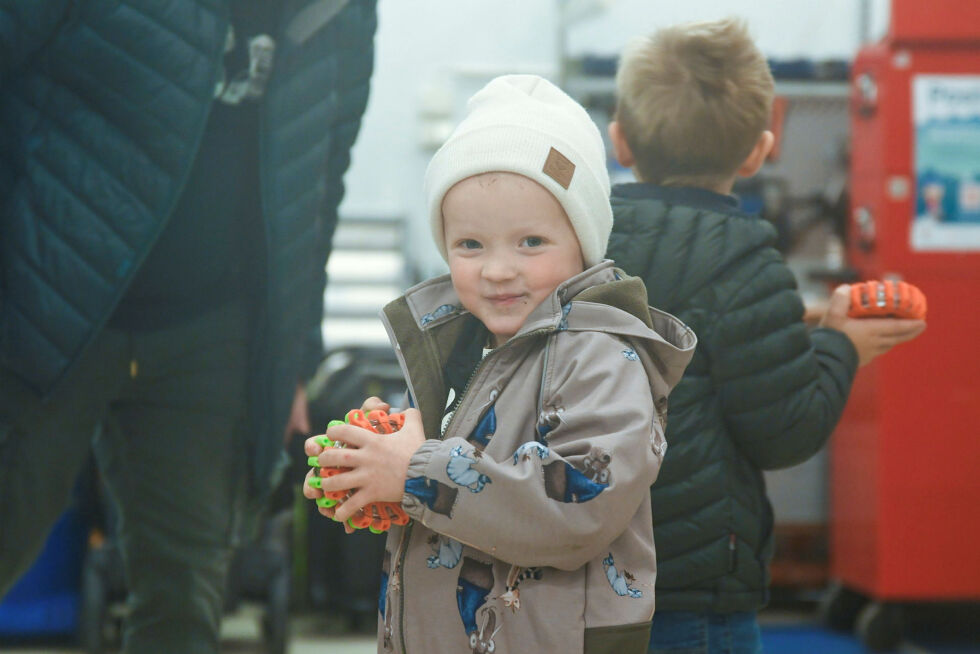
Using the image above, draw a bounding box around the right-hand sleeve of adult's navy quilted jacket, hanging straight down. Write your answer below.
[300,2,377,379]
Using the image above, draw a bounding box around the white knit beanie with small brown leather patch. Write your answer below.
[425,75,612,266]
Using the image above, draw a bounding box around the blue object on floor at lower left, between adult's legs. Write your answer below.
[0,509,87,636]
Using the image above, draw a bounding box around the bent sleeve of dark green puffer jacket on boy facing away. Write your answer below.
[702,250,857,470]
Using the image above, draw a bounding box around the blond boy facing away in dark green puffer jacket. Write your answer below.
[607,19,925,653]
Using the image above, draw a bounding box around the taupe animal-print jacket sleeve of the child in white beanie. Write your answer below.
[403,333,664,570]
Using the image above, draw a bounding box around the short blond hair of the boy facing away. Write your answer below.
[616,18,773,187]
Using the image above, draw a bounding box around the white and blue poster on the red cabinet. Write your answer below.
[910,75,980,251]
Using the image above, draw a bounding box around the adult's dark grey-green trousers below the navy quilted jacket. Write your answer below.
[0,303,249,654]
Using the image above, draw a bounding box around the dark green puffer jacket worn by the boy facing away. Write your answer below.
[607,184,857,612]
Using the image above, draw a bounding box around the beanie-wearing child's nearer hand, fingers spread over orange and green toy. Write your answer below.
[312,409,425,521]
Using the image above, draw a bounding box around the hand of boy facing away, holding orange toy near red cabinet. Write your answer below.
[820,284,926,366]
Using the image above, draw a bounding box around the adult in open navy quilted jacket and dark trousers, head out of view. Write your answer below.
[0,0,376,654]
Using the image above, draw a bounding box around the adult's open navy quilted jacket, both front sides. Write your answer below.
[0,0,376,492]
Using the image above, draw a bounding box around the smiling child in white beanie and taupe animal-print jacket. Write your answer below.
[305,75,695,654]
